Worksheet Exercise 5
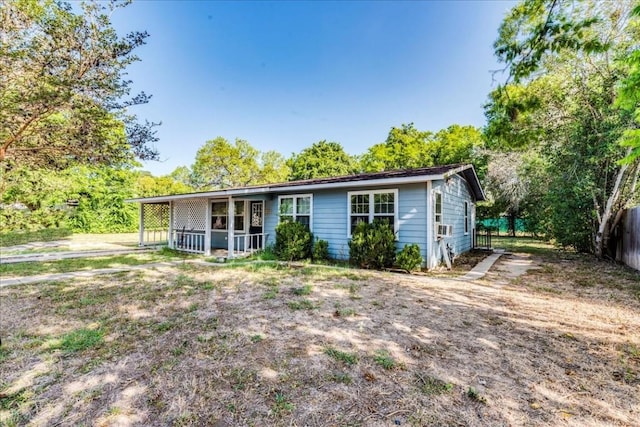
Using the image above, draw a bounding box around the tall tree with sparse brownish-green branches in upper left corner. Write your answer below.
[0,0,157,169]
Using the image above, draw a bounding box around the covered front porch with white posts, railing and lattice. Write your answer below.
[139,196,269,258]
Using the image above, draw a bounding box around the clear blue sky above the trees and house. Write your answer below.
[112,1,514,175]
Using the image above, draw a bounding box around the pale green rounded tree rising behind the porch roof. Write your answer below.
[191,136,289,190]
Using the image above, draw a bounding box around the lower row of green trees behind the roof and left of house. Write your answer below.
[0,120,484,233]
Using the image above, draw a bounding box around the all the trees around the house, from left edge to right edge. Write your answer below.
[0,0,640,256]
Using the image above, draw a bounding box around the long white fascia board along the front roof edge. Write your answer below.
[125,174,444,203]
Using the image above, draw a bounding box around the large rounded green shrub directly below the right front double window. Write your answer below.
[349,221,396,269]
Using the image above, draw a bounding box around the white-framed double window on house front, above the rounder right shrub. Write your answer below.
[348,190,398,237]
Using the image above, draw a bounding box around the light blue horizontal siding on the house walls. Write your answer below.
[172,175,475,268]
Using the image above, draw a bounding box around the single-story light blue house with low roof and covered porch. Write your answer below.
[129,165,485,268]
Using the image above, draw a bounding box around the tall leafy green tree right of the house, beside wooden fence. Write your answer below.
[486,0,640,256]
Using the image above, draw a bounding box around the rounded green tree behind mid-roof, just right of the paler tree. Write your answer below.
[287,140,358,181]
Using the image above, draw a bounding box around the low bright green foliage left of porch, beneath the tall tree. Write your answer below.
[0,165,138,233]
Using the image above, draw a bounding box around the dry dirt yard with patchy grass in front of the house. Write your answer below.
[0,246,640,427]
